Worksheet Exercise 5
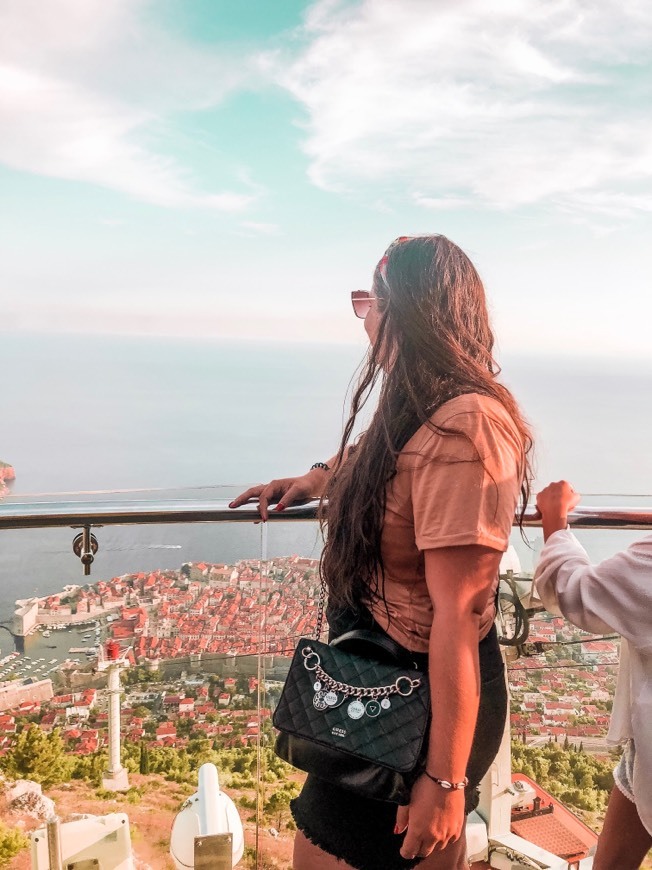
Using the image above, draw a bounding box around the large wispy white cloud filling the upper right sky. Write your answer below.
[260,0,652,213]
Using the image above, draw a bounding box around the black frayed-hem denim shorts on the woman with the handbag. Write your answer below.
[291,614,507,870]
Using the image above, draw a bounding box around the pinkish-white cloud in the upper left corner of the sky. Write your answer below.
[0,0,254,211]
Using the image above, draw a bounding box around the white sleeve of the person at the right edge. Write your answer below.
[534,530,652,652]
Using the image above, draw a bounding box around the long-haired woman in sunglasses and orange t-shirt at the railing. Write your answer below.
[232,235,531,870]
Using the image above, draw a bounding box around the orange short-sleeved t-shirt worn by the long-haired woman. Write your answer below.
[368,393,522,652]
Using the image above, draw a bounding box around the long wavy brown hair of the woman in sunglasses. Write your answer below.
[320,235,532,607]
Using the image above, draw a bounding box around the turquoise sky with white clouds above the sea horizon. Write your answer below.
[0,0,652,363]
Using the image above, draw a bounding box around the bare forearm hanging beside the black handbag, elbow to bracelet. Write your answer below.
[427,615,480,782]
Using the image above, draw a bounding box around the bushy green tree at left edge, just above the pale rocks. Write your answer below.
[2,725,74,788]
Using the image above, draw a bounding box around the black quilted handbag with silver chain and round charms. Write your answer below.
[272,630,430,803]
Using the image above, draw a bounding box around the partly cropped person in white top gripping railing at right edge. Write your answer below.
[534,480,652,870]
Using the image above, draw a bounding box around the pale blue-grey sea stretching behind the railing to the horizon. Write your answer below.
[0,333,652,657]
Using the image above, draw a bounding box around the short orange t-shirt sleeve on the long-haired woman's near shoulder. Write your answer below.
[405,397,522,552]
